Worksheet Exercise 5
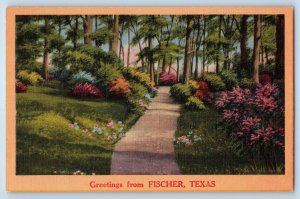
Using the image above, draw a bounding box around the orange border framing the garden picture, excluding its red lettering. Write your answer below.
[6,7,294,192]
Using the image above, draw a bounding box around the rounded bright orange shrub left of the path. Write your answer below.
[109,78,131,97]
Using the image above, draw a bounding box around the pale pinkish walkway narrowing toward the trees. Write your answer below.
[111,87,180,174]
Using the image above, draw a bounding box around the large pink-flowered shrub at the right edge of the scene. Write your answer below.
[215,84,284,168]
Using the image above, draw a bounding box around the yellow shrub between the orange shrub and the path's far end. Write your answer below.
[123,67,155,89]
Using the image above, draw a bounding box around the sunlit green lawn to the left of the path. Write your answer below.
[17,82,137,175]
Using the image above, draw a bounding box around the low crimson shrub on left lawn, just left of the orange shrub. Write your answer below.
[71,83,103,97]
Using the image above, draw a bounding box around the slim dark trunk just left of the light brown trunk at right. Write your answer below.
[238,15,248,76]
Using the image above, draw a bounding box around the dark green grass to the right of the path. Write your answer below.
[175,107,281,174]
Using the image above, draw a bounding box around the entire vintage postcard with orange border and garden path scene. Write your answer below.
[6,7,294,192]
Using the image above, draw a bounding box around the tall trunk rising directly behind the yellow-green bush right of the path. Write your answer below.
[184,15,193,84]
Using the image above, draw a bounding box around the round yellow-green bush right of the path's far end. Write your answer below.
[170,83,192,103]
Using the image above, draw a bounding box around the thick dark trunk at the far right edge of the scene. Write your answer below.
[275,15,284,79]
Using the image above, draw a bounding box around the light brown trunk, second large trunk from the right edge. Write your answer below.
[253,15,261,84]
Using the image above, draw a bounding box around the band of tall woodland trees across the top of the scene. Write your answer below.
[16,15,284,83]
